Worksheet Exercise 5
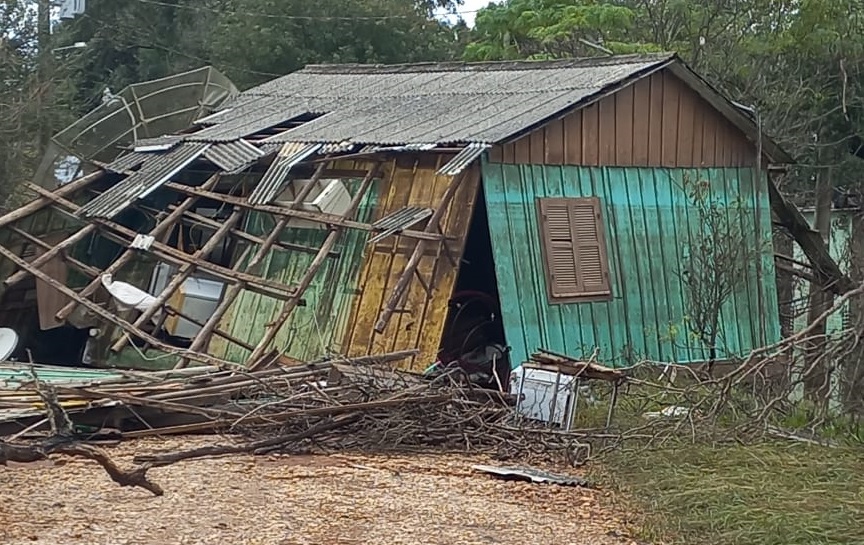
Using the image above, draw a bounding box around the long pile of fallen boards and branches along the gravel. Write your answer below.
[0,352,588,493]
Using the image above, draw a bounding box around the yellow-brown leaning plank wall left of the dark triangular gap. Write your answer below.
[343,156,480,370]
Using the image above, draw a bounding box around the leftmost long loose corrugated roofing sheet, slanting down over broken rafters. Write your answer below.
[79,143,210,218]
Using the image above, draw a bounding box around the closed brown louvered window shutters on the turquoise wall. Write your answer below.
[539,197,612,302]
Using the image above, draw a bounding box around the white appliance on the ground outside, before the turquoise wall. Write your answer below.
[510,366,575,429]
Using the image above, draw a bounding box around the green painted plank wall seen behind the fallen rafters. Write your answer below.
[210,180,381,363]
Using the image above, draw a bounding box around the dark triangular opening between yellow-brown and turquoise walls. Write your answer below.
[436,184,510,391]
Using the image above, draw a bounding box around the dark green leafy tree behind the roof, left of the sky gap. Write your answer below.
[211,0,470,87]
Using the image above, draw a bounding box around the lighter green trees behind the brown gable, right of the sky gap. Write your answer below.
[464,0,864,188]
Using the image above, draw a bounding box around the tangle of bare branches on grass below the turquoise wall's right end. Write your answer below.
[594,284,864,450]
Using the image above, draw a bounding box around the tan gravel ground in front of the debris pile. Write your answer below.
[0,438,633,545]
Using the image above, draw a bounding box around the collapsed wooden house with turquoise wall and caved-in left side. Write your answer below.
[0,54,852,376]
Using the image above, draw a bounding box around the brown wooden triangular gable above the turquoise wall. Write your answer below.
[489,70,756,168]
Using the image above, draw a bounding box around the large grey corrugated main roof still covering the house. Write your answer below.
[179,54,673,145]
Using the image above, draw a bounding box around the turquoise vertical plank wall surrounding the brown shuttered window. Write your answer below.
[483,162,780,366]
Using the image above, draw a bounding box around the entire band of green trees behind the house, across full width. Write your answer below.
[0,0,864,201]
